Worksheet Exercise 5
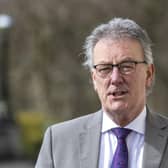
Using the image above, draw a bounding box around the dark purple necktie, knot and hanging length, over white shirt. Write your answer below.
[111,128,131,168]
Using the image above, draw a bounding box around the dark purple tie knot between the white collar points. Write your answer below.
[112,128,131,139]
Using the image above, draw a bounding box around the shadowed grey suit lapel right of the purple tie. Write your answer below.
[143,112,167,168]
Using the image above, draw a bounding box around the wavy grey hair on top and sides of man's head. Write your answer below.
[83,18,153,70]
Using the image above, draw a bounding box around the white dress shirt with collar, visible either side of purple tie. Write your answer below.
[99,107,146,168]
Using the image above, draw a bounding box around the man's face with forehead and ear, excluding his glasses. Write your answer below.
[92,38,154,120]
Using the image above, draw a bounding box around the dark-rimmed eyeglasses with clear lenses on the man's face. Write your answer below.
[93,60,147,78]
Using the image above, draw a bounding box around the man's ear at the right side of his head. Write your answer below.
[146,64,155,88]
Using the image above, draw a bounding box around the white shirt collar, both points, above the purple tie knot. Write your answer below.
[102,107,146,134]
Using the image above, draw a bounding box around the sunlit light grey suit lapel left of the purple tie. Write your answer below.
[79,112,102,168]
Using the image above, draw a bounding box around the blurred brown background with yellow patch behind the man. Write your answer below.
[0,0,168,168]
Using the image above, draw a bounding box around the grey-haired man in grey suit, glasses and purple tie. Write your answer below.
[36,18,168,168]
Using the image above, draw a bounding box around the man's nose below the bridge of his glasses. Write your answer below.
[110,67,123,84]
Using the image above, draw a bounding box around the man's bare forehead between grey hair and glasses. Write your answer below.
[93,38,144,63]
